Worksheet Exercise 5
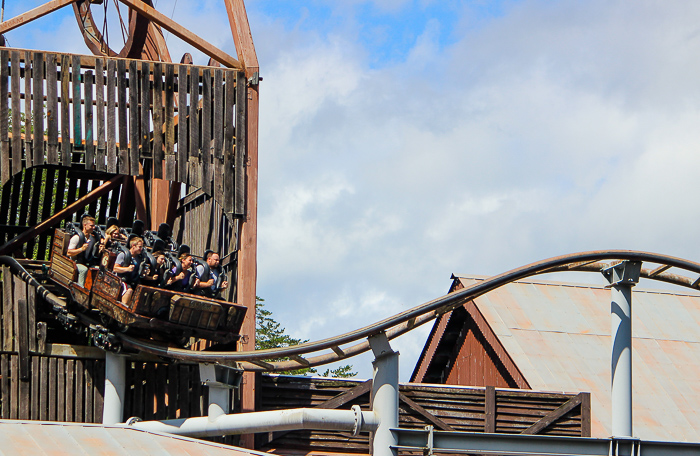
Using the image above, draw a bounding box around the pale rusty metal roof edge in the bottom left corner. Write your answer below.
[0,420,266,456]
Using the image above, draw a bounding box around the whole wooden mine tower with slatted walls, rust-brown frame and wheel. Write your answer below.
[0,0,259,442]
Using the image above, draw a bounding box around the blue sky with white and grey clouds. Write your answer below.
[5,0,700,381]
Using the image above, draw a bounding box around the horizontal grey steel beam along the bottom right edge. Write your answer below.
[391,429,700,456]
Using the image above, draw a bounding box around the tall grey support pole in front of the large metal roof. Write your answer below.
[603,261,642,437]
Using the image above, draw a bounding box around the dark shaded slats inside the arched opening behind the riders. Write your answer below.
[0,165,120,260]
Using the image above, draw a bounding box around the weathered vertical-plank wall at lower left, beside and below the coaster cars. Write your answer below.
[0,267,216,423]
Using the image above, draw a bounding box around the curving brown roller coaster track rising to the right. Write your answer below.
[0,250,700,371]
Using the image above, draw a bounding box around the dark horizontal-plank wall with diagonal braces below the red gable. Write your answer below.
[257,375,590,454]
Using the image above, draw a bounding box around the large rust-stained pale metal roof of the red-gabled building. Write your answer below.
[459,277,700,442]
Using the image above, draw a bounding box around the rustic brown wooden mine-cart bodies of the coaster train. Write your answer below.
[49,229,246,344]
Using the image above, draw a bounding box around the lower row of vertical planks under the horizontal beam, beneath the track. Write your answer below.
[0,351,213,423]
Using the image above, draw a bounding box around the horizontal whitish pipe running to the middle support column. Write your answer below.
[128,408,378,437]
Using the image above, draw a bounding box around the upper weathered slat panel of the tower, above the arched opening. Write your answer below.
[0,48,247,216]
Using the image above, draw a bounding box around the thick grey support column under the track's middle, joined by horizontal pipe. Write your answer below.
[369,332,399,456]
